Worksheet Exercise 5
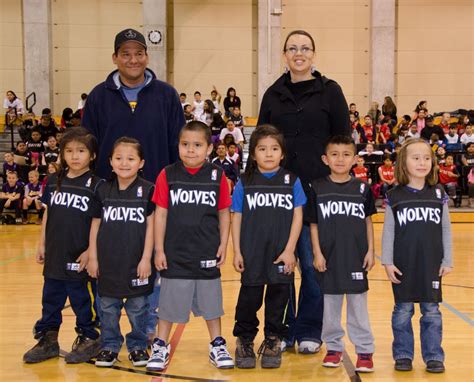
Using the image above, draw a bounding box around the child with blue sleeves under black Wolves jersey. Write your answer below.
[232,125,306,369]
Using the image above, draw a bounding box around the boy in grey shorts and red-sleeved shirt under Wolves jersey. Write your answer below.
[147,121,234,370]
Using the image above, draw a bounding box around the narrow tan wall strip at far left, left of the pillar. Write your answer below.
[0,0,25,103]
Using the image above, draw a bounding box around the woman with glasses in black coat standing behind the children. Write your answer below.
[258,31,351,353]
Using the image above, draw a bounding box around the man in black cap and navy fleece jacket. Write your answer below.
[82,28,185,182]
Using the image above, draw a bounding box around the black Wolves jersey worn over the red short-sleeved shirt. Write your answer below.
[160,162,223,279]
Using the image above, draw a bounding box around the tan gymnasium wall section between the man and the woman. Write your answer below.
[168,0,257,115]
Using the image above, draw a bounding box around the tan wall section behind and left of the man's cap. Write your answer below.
[51,0,143,114]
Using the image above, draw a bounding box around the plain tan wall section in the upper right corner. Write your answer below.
[395,0,474,114]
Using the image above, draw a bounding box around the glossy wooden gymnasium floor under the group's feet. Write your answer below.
[0,213,474,382]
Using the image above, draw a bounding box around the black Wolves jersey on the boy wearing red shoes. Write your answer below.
[308,177,376,294]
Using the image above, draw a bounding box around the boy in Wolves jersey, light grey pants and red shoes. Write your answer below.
[308,135,376,372]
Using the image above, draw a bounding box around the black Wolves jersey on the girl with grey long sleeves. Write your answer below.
[387,185,447,302]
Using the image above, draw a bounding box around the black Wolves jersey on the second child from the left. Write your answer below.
[97,177,155,298]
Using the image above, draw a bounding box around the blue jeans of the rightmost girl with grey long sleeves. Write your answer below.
[392,302,444,363]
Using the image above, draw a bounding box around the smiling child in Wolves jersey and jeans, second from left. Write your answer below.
[87,137,155,367]
